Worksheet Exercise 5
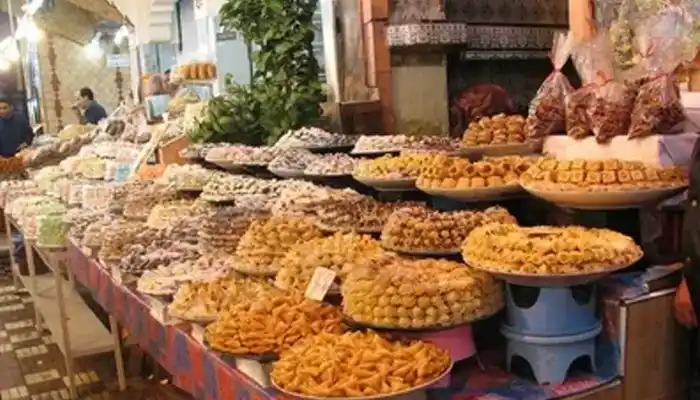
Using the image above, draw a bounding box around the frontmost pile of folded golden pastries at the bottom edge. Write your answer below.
[271,332,452,398]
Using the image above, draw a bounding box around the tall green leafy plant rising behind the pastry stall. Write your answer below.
[212,0,324,143]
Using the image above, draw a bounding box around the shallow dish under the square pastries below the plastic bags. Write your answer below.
[522,185,685,210]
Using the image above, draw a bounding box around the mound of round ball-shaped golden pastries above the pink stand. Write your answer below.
[341,259,503,329]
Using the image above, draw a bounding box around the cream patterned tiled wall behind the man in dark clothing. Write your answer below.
[38,2,131,132]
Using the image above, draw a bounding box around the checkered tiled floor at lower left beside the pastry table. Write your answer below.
[0,278,189,400]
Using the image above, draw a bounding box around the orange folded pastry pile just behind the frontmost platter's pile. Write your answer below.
[206,295,344,355]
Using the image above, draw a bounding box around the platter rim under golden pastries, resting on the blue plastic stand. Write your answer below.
[464,255,642,287]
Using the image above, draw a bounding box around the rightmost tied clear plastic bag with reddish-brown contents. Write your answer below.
[629,9,694,138]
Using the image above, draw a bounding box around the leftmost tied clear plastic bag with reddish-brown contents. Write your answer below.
[526,33,573,138]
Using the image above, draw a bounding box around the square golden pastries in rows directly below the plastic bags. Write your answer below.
[522,158,688,191]
